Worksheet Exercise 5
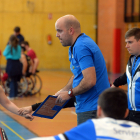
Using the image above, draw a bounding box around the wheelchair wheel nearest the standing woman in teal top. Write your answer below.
[17,76,28,97]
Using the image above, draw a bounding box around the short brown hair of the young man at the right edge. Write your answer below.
[125,27,140,41]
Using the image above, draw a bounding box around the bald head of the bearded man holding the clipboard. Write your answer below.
[55,15,81,46]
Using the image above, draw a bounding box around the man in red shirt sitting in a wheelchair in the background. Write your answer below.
[21,41,39,74]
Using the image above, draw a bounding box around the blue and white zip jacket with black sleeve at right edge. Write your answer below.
[113,55,140,111]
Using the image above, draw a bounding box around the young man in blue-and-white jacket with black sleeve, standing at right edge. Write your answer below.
[112,28,140,125]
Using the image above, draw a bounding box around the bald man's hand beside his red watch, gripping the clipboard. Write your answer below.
[55,91,71,103]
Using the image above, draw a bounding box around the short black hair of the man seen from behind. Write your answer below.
[98,88,128,119]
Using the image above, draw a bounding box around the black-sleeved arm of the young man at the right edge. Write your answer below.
[111,72,127,87]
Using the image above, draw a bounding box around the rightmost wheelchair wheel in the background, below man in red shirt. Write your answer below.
[32,74,42,95]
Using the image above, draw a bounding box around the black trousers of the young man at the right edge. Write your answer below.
[125,110,140,125]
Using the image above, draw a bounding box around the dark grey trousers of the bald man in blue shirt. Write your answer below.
[77,110,97,125]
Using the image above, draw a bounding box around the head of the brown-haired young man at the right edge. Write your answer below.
[125,27,140,56]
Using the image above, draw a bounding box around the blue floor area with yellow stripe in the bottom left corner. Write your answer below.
[0,111,37,140]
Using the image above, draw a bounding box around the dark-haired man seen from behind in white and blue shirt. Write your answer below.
[27,88,140,140]
